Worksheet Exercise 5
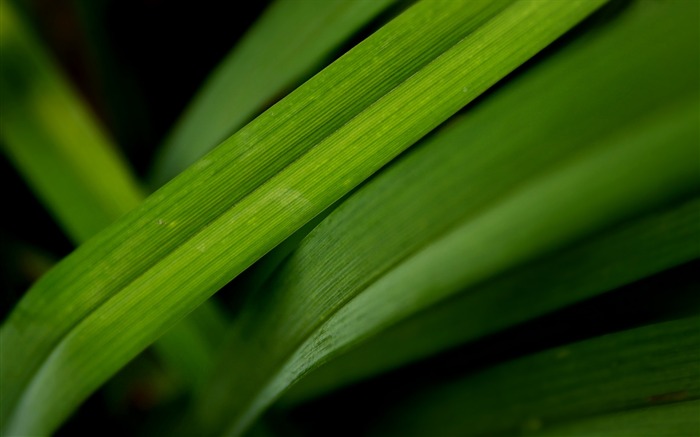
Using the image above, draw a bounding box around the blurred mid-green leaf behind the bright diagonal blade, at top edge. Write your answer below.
[153,0,396,185]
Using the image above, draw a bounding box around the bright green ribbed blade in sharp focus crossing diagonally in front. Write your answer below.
[0,0,604,434]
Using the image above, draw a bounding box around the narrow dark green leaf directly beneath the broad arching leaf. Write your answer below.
[281,199,700,405]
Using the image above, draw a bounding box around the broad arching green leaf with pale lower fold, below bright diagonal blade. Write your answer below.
[197,0,700,433]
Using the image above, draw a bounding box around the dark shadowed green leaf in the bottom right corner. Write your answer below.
[376,317,700,436]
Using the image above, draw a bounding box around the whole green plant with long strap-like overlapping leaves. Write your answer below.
[0,0,700,435]
